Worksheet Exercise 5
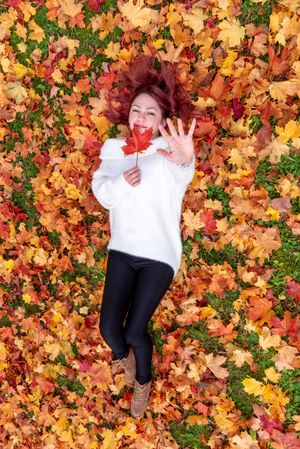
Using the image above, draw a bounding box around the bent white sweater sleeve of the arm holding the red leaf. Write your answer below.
[92,160,131,209]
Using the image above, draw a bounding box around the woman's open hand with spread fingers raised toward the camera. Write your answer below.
[157,118,196,165]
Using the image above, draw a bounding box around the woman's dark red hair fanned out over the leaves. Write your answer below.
[104,55,199,124]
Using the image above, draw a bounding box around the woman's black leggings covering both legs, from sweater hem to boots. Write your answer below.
[100,250,174,384]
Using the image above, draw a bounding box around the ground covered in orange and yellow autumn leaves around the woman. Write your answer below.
[0,0,300,449]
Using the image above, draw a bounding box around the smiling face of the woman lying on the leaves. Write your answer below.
[128,93,165,137]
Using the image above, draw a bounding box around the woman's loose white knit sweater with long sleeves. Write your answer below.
[92,137,195,276]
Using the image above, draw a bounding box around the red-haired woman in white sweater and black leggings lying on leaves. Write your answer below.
[92,56,196,417]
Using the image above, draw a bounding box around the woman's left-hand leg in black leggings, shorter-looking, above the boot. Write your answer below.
[100,250,136,359]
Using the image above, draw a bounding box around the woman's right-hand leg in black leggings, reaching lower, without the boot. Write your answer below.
[125,259,174,384]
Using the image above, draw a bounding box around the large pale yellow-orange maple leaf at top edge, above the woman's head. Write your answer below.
[119,0,158,28]
